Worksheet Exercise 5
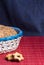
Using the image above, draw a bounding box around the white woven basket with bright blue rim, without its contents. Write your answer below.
[0,27,22,54]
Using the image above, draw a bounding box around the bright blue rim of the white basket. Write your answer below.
[0,27,23,41]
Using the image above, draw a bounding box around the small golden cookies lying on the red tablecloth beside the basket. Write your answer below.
[5,52,24,62]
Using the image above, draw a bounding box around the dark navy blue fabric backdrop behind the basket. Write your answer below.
[0,0,44,36]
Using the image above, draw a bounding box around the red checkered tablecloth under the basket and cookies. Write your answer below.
[0,36,44,65]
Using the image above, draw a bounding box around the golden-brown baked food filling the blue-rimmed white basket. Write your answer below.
[0,25,17,38]
